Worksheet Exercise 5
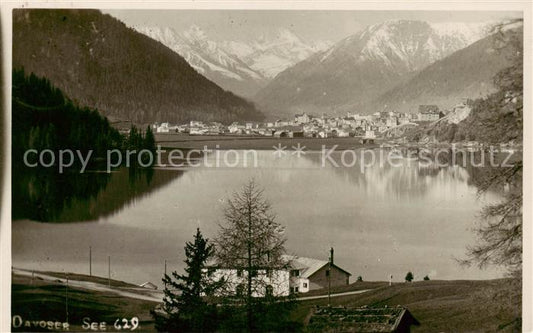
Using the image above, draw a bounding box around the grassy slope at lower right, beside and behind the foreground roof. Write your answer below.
[293,279,521,332]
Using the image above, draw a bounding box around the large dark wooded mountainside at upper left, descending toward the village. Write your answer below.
[13,9,263,125]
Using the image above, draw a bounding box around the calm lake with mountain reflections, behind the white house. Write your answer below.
[12,151,504,286]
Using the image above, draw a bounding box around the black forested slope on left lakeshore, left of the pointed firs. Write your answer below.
[12,69,123,163]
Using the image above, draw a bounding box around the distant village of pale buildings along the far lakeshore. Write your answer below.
[152,103,466,139]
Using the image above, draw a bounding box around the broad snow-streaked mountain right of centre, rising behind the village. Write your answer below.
[255,20,496,116]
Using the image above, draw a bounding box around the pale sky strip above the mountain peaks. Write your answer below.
[104,10,522,42]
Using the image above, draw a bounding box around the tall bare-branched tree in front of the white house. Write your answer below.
[215,180,288,332]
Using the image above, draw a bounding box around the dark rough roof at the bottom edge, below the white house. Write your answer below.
[308,306,420,333]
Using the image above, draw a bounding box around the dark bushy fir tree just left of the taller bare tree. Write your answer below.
[154,229,223,332]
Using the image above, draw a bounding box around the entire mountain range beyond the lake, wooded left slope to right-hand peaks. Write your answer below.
[13,10,509,124]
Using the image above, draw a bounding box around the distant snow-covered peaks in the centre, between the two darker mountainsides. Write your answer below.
[133,25,331,97]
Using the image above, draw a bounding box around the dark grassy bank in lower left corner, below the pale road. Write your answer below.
[11,273,157,332]
